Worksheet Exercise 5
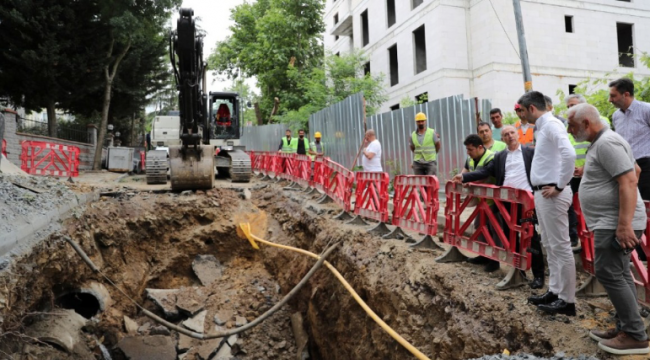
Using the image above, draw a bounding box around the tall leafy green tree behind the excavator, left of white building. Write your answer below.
[208,0,325,118]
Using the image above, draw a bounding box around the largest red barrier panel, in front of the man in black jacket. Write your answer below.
[444,182,535,270]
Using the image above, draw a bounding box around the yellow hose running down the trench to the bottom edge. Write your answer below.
[239,223,431,360]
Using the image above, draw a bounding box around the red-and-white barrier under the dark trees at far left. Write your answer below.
[20,141,80,177]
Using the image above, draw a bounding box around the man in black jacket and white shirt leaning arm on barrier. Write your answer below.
[453,125,544,289]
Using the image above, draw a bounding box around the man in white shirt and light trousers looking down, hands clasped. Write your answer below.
[518,91,576,316]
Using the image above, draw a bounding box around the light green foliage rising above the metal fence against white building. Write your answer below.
[276,51,387,128]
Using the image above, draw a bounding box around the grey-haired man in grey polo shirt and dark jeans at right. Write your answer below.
[569,104,650,355]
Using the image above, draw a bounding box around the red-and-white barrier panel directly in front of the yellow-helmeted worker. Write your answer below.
[393,175,440,236]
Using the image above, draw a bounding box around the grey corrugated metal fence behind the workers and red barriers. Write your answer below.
[242,93,491,184]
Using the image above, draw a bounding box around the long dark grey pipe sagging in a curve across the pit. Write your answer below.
[63,236,339,340]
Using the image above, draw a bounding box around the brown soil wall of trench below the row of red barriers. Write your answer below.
[253,188,611,360]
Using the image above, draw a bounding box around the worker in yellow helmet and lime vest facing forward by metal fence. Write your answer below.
[409,113,440,175]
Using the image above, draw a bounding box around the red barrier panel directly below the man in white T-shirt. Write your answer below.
[354,172,390,222]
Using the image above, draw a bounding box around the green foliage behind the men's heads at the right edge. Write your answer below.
[553,53,650,120]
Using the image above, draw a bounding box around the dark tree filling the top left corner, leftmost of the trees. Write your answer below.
[0,0,100,137]
